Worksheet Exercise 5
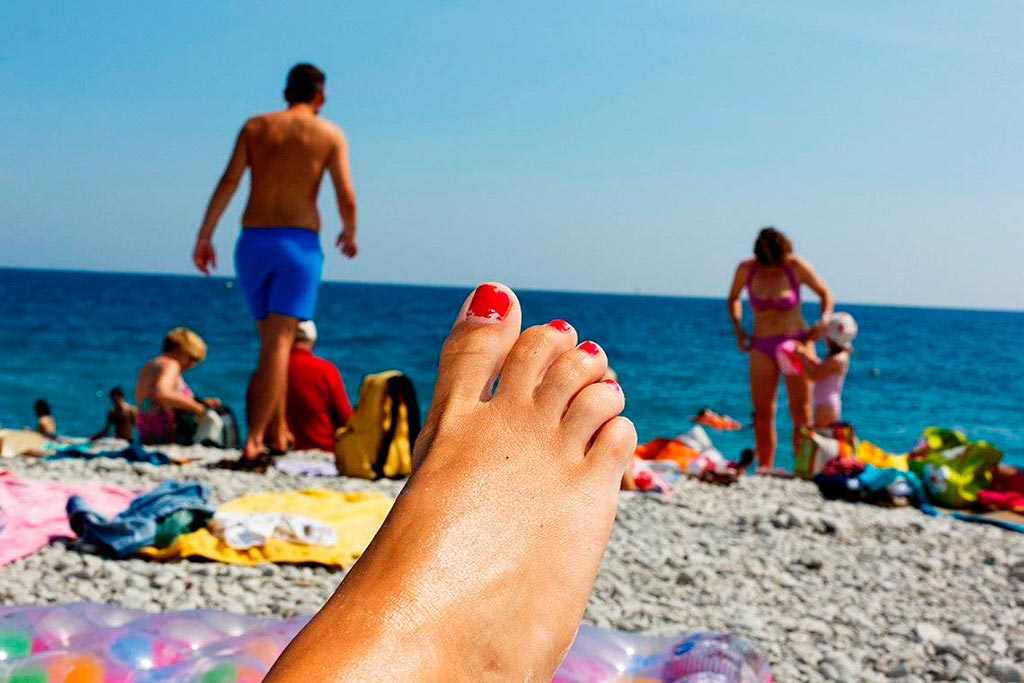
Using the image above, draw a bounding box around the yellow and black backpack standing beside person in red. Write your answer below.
[334,370,420,479]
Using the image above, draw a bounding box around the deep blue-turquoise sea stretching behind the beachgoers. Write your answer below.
[0,269,1024,465]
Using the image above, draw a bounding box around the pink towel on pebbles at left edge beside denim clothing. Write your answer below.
[0,470,134,565]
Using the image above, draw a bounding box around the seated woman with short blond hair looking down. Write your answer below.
[135,328,220,443]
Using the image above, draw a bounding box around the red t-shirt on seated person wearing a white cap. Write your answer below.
[285,347,352,452]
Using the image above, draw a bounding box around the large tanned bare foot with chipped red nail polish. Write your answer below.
[266,284,636,683]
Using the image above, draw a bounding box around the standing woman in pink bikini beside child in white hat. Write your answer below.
[727,227,834,471]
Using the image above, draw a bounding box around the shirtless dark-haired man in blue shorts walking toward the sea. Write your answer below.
[193,63,358,461]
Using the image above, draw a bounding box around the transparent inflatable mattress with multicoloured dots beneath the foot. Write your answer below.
[0,603,772,683]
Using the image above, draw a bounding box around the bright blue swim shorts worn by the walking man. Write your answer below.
[234,227,324,321]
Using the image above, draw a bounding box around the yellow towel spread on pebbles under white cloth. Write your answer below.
[139,488,393,568]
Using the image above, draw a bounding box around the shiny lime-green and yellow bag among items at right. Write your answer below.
[909,438,1002,508]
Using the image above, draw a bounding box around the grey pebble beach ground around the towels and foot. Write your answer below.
[0,449,1024,683]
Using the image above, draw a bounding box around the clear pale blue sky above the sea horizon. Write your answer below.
[0,0,1024,309]
